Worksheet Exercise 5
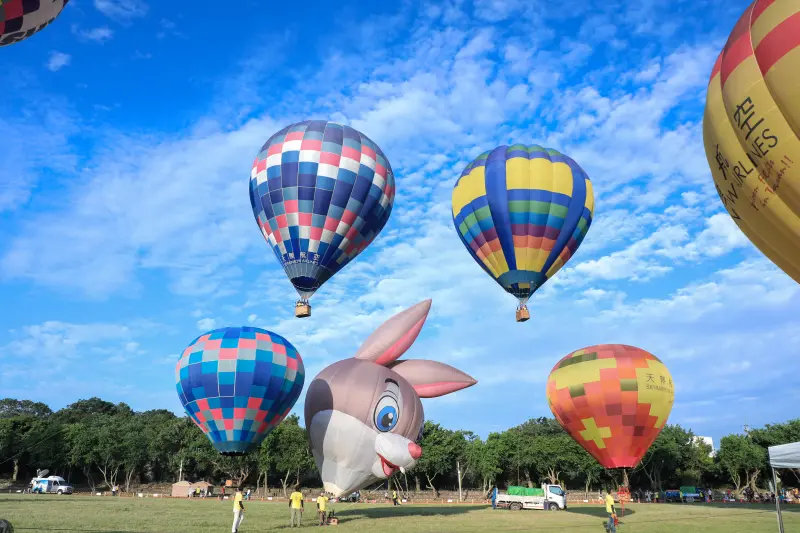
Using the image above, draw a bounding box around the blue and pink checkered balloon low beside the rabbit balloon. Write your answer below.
[175,326,305,456]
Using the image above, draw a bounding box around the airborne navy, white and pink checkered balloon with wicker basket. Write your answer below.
[250,120,395,317]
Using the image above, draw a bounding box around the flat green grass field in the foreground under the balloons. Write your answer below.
[0,494,800,533]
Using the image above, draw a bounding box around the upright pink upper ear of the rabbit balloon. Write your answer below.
[353,300,431,365]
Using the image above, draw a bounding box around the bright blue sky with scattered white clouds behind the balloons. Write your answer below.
[0,0,800,442]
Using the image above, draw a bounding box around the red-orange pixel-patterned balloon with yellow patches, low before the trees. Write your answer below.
[547,344,675,468]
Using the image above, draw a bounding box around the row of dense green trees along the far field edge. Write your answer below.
[0,398,800,496]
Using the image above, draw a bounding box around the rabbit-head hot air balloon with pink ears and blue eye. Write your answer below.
[305,300,477,497]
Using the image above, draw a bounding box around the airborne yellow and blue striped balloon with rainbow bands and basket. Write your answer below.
[453,144,594,322]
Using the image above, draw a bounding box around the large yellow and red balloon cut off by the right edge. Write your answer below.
[703,0,800,282]
